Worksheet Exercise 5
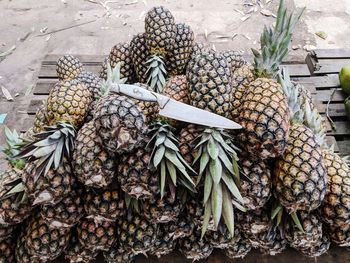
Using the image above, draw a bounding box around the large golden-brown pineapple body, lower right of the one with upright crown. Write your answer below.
[274,123,327,212]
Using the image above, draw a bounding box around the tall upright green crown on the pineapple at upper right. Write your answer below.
[252,0,304,78]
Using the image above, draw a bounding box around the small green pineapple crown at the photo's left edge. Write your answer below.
[0,126,29,170]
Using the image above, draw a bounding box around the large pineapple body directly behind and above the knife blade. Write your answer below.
[187,53,232,117]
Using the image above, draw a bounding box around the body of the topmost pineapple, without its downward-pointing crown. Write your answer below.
[145,6,176,57]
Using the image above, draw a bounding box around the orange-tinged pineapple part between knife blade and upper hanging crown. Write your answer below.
[163,75,190,104]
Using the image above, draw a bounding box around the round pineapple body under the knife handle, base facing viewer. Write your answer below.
[94,95,148,154]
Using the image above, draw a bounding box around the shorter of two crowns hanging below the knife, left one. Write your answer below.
[147,122,196,198]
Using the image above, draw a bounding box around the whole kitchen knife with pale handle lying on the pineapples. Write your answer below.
[111,83,242,130]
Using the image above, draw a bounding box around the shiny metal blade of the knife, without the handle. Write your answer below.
[159,99,242,130]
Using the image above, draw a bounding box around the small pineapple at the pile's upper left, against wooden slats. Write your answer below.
[56,55,84,80]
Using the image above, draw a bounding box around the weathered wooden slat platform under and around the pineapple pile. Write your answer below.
[13,50,350,263]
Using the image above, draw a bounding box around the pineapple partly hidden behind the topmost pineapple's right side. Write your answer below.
[166,23,194,76]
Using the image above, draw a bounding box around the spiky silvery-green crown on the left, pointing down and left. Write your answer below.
[14,122,76,179]
